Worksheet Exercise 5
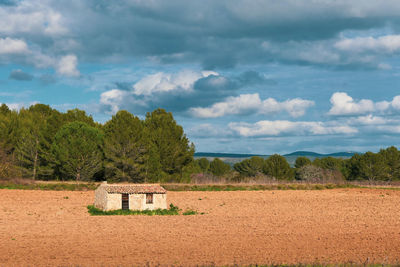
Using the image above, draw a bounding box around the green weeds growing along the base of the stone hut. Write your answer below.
[87,204,181,216]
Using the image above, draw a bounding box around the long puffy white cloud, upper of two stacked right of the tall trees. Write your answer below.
[190,93,314,118]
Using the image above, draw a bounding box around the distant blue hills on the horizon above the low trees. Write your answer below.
[194,151,355,166]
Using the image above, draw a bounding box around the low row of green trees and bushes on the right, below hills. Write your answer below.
[219,146,400,182]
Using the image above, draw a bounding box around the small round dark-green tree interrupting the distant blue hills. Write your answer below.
[263,154,294,180]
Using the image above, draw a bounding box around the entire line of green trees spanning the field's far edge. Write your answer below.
[0,104,400,183]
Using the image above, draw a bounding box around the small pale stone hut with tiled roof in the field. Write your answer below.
[94,182,167,213]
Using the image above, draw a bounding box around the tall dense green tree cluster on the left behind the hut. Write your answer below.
[0,104,195,182]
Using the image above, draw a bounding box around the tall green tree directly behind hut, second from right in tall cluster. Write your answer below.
[104,111,147,182]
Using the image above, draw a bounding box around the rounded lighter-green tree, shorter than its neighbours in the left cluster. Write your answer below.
[52,122,103,181]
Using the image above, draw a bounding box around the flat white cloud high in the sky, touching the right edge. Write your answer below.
[334,35,400,53]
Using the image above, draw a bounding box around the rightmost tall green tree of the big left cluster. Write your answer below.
[144,109,194,181]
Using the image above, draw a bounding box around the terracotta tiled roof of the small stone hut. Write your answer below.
[102,184,167,194]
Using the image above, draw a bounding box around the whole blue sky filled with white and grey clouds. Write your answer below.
[0,0,400,154]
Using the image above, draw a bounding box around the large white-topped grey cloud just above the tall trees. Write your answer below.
[101,69,241,113]
